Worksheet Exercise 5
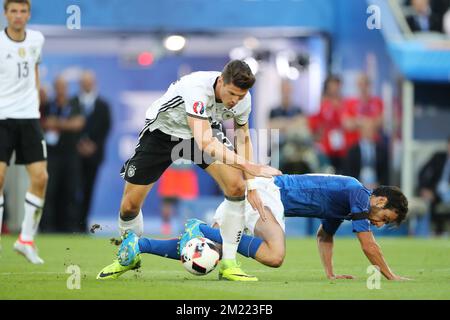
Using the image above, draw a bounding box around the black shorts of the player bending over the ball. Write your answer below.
[120,124,233,185]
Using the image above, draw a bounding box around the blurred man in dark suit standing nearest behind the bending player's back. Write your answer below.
[71,71,111,232]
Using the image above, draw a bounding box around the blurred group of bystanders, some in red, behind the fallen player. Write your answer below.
[269,74,388,188]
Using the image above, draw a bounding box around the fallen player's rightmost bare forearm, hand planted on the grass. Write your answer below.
[358,231,409,281]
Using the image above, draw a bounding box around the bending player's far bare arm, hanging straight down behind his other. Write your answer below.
[234,121,267,221]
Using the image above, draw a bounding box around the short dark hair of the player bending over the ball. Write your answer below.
[222,60,256,90]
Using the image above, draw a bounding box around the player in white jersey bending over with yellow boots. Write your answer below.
[97,60,281,281]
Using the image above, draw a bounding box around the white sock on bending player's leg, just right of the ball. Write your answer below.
[220,199,245,260]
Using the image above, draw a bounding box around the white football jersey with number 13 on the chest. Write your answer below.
[0,29,44,119]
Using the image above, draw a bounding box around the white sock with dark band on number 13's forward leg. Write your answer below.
[20,192,44,241]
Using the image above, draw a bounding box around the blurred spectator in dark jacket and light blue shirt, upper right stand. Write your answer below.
[406,0,442,32]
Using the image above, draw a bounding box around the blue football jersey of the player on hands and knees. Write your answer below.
[275,174,371,234]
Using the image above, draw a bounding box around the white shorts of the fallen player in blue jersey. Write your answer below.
[213,177,285,234]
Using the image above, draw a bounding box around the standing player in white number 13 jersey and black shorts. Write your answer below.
[0,0,48,264]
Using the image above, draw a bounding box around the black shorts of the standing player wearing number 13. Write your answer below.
[0,119,47,165]
